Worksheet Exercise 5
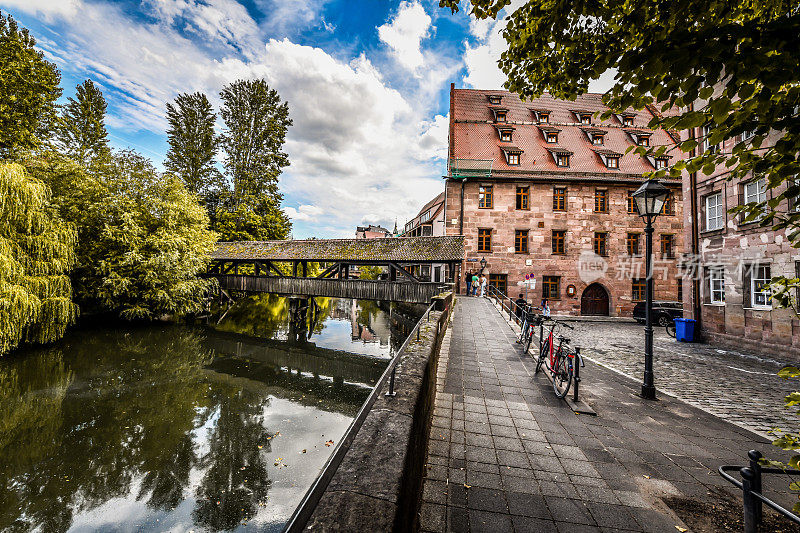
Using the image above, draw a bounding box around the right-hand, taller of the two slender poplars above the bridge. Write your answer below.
[220,79,292,203]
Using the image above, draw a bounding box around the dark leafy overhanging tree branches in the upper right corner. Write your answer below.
[440,0,800,235]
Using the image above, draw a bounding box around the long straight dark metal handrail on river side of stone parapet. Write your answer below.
[283,302,436,533]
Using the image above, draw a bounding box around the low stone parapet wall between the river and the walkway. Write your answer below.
[306,295,454,532]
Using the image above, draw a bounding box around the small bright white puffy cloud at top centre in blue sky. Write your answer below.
[378,2,431,71]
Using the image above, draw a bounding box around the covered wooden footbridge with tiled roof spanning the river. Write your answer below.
[208,236,464,303]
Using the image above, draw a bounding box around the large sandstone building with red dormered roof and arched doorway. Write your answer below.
[445,85,683,316]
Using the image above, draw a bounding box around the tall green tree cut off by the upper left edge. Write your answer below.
[0,11,61,159]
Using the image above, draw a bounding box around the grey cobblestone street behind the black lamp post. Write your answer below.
[528,321,800,435]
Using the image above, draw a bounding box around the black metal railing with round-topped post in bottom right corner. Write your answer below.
[719,450,800,533]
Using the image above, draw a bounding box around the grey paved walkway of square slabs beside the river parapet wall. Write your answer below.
[420,297,789,533]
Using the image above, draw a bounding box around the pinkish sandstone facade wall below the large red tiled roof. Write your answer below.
[445,178,684,316]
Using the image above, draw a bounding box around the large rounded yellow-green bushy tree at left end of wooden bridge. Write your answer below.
[28,152,216,319]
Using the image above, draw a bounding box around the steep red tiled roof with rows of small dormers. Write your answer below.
[451,89,684,176]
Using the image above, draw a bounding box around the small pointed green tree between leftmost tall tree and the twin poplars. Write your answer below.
[56,80,109,164]
